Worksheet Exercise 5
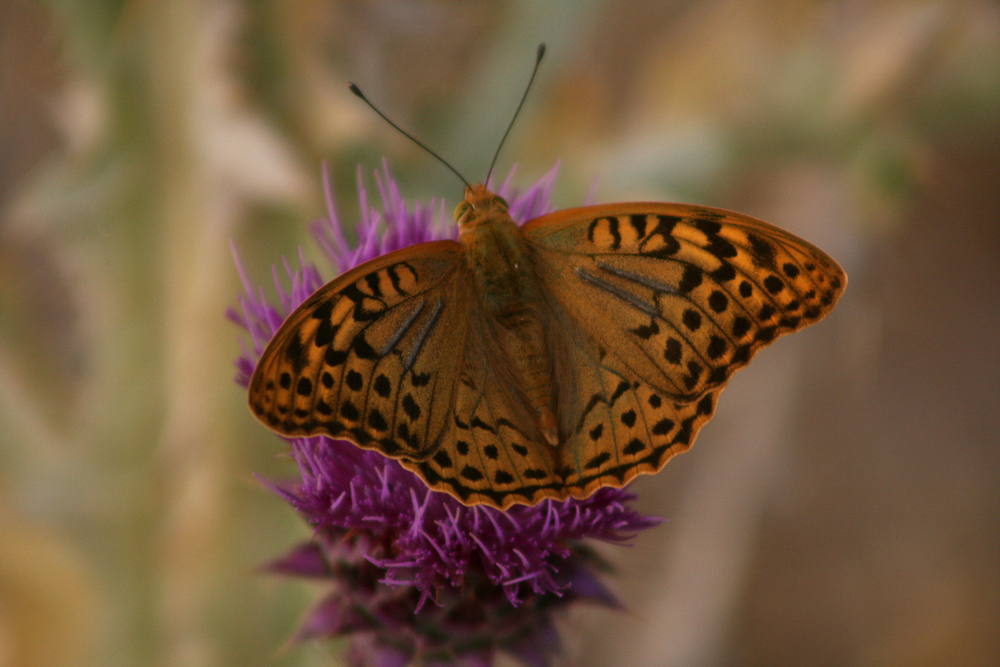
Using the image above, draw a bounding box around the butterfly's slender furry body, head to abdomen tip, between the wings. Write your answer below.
[455,185,559,445]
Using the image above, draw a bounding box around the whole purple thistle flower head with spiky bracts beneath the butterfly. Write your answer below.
[227,161,659,667]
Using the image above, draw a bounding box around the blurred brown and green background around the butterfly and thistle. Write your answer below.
[0,0,1000,667]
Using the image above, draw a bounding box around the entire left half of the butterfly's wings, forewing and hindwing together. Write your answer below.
[249,241,562,507]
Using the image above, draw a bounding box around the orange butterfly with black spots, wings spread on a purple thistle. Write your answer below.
[249,184,847,509]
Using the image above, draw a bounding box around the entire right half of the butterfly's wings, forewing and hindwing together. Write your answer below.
[522,203,847,496]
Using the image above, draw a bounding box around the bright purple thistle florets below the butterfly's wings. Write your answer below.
[272,436,658,607]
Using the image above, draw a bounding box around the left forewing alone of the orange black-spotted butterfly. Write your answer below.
[249,241,468,459]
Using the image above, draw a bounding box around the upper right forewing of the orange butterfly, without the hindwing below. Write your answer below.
[524,203,846,402]
